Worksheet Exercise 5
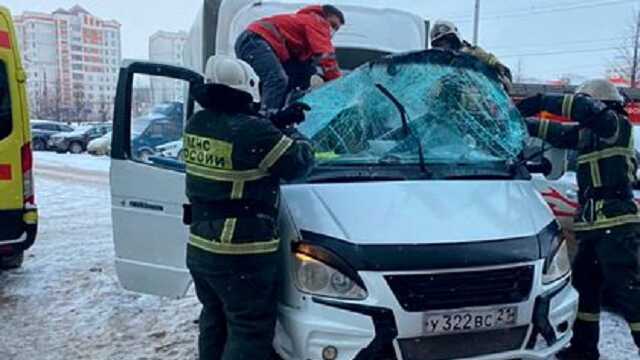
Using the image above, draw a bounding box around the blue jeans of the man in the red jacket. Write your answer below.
[235,31,316,112]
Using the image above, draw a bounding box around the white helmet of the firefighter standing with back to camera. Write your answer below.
[204,55,260,103]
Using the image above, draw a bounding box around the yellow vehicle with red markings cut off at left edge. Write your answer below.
[0,7,38,270]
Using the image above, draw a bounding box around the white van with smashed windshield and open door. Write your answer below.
[111,0,578,360]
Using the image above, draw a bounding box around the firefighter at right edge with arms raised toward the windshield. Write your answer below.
[517,80,640,360]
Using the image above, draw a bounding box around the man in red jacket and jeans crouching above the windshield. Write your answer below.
[235,5,345,111]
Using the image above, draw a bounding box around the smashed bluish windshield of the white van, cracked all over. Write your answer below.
[300,50,526,165]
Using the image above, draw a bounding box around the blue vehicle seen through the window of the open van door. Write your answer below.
[131,102,184,162]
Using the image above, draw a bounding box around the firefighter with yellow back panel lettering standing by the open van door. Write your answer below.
[184,55,313,360]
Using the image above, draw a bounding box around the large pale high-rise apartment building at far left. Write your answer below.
[15,5,122,120]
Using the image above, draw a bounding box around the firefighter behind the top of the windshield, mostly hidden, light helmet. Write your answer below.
[431,20,513,92]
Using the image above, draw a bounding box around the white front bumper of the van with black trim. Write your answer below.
[276,263,578,360]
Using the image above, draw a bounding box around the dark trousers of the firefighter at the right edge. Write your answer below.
[572,224,640,354]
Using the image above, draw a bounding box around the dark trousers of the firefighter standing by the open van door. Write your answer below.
[187,248,277,360]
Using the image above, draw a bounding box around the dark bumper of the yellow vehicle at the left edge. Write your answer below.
[0,209,38,255]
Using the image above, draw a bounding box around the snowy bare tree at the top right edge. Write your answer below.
[610,11,640,88]
